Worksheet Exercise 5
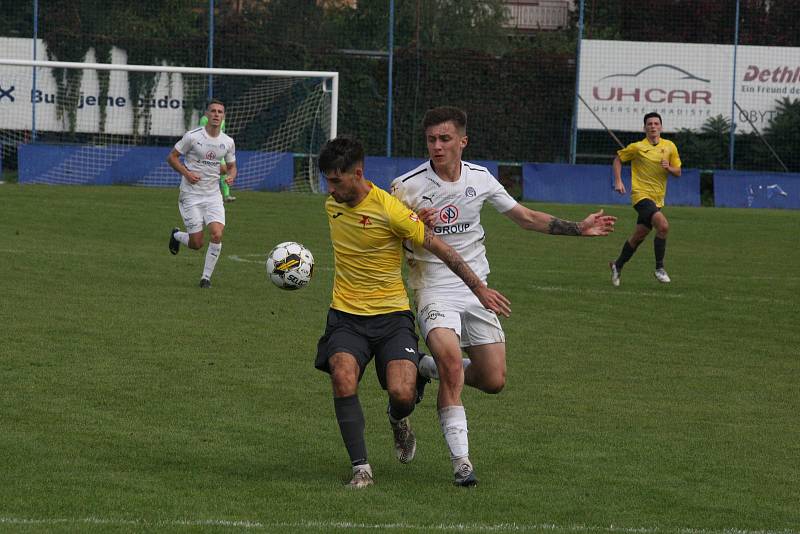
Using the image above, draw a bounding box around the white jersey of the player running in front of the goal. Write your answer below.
[175,126,236,195]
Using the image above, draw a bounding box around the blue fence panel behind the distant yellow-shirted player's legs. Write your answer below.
[522,163,700,206]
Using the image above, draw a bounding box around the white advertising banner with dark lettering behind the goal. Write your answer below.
[0,37,196,136]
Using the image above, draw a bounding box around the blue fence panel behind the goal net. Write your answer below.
[18,143,294,191]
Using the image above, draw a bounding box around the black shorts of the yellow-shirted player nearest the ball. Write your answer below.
[314,308,419,389]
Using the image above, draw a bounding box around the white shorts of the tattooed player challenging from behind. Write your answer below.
[414,286,506,347]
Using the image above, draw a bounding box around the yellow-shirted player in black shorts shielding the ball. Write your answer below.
[315,136,511,488]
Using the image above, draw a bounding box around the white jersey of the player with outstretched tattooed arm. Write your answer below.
[392,161,517,289]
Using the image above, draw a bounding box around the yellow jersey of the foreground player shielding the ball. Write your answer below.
[325,182,425,315]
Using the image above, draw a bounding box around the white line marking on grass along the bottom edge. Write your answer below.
[0,517,797,534]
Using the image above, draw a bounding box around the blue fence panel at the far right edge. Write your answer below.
[714,171,800,213]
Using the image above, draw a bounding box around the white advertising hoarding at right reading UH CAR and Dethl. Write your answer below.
[578,40,800,133]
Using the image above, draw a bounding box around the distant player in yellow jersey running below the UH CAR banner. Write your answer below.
[609,112,681,287]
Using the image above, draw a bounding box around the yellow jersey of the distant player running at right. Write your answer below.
[617,138,681,208]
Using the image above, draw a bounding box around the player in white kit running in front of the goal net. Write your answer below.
[167,100,237,288]
